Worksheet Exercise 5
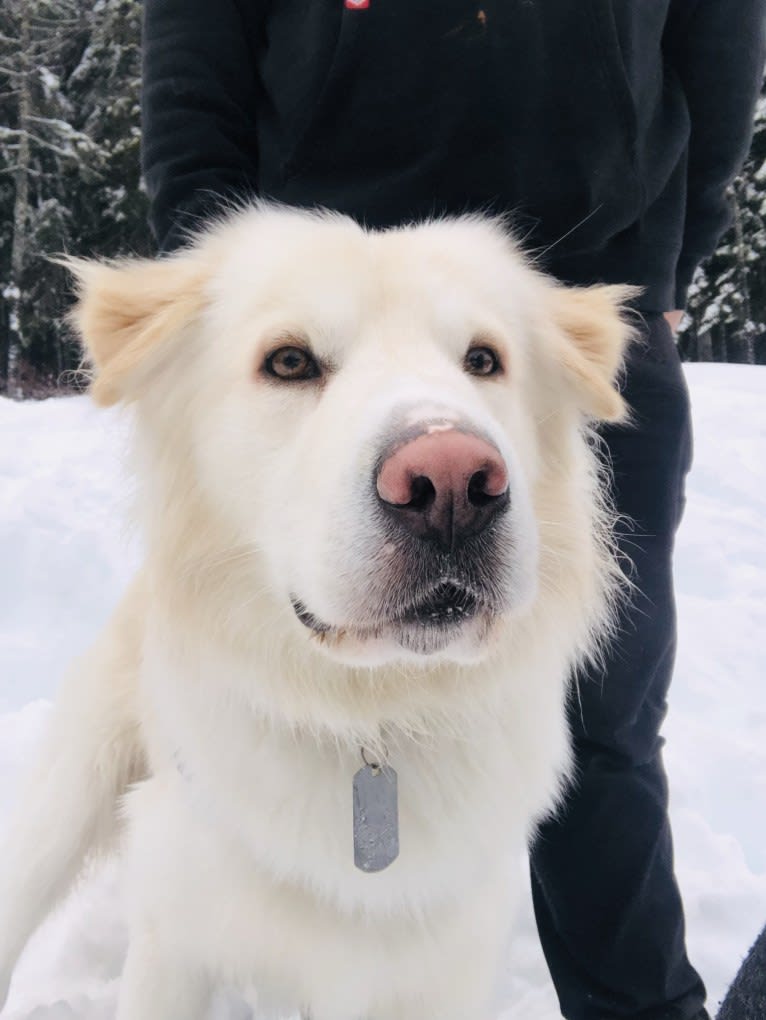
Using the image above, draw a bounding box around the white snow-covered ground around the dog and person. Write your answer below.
[0,365,766,1020]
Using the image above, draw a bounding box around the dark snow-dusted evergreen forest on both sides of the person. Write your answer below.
[0,0,766,398]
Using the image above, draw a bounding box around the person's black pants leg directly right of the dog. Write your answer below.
[531,314,705,1020]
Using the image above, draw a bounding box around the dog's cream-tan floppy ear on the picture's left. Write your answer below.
[57,254,207,407]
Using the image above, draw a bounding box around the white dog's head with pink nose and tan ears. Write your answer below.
[65,208,629,663]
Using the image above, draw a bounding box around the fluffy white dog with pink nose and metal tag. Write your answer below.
[0,207,630,1020]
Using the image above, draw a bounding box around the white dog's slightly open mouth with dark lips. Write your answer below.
[291,580,481,646]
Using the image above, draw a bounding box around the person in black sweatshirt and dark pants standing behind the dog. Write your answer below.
[143,0,766,1020]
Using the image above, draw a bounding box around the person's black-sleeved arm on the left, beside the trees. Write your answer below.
[142,0,262,251]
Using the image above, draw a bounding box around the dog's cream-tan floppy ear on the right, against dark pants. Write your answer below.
[553,286,641,421]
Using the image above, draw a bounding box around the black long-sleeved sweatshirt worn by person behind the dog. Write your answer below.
[143,0,766,311]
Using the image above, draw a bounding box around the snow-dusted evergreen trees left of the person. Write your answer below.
[0,0,148,396]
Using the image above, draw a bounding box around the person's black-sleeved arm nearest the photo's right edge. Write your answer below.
[665,0,766,308]
